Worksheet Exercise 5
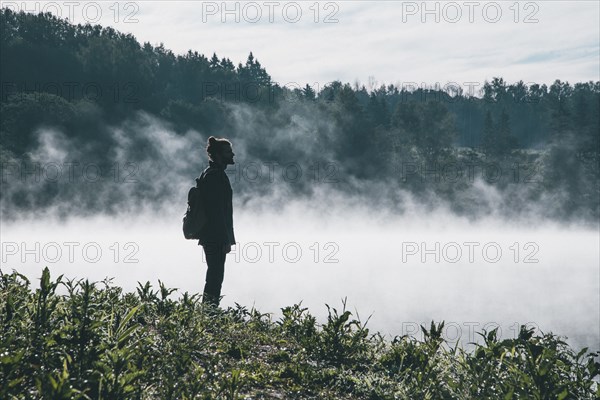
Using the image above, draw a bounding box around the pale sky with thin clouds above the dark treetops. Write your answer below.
[2,0,600,92]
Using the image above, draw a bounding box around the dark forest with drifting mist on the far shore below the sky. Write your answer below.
[0,9,600,223]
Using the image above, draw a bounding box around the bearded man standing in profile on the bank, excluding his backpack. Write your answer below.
[198,136,235,307]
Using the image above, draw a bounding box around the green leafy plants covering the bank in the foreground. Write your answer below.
[0,268,600,400]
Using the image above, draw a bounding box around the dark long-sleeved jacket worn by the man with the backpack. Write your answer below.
[198,161,235,246]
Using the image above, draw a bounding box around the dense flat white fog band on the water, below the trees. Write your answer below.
[2,195,600,348]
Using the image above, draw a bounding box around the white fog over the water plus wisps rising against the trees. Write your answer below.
[0,106,600,349]
